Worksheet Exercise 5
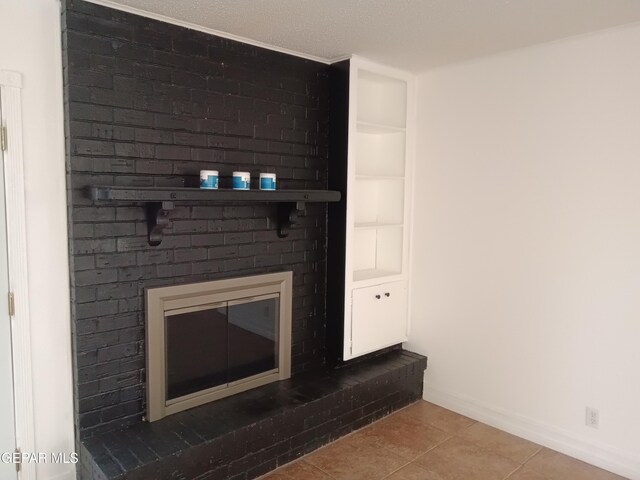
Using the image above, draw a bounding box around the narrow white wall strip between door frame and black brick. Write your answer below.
[0,0,74,480]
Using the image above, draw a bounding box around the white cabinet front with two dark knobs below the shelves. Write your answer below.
[351,281,407,357]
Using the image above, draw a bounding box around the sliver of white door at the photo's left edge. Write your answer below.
[0,100,18,480]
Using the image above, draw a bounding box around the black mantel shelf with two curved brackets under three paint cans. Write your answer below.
[88,185,341,246]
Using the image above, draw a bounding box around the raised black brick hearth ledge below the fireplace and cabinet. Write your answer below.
[80,350,427,480]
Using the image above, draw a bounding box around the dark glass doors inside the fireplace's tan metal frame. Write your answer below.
[165,294,280,401]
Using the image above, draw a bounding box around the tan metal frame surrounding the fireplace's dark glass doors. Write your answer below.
[146,272,293,422]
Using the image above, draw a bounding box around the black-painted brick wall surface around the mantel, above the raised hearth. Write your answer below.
[62,0,329,437]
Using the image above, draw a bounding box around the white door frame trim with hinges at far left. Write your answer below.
[0,70,36,480]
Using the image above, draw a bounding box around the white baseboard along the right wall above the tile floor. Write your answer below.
[423,384,640,480]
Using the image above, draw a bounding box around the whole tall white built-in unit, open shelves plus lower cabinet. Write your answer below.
[329,57,415,360]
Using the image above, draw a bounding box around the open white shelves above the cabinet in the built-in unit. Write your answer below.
[349,67,407,283]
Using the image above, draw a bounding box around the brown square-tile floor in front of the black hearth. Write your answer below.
[262,401,622,480]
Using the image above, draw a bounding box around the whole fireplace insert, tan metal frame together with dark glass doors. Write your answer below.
[146,272,292,421]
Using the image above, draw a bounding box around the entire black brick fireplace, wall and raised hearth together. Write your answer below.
[62,0,425,478]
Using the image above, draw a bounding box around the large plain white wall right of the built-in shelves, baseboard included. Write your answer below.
[408,24,640,478]
